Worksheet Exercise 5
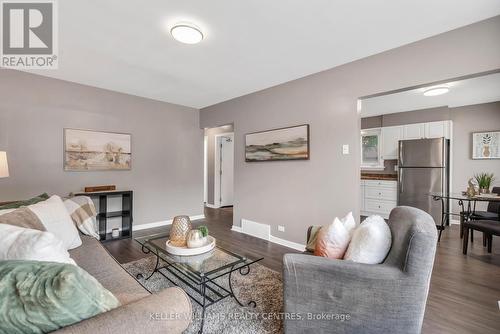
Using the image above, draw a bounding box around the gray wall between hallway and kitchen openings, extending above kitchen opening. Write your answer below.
[200,17,500,243]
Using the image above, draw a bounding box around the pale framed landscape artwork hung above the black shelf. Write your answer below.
[64,129,132,171]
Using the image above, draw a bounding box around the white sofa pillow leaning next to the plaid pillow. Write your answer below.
[28,195,82,249]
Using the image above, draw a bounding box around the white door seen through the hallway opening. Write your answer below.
[219,135,234,206]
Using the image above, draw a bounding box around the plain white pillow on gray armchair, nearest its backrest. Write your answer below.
[344,216,392,264]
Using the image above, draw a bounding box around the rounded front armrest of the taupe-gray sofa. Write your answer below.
[56,287,192,334]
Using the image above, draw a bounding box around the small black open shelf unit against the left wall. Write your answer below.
[75,190,133,242]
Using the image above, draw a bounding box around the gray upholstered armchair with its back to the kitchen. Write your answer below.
[283,207,437,334]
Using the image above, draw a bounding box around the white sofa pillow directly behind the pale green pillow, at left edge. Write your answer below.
[0,224,76,265]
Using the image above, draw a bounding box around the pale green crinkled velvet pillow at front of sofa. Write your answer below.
[0,261,119,334]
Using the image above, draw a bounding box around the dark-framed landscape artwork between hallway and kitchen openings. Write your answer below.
[245,124,309,162]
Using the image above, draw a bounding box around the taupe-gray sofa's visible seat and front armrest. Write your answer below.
[56,236,192,334]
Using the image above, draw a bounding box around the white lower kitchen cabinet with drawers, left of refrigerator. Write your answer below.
[361,180,397,219]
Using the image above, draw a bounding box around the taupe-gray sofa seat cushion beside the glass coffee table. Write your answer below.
[69,235,152,305]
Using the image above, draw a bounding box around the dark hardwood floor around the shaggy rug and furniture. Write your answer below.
[104,208,500,334]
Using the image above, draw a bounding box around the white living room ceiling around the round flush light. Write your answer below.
[25,0,500,108]
